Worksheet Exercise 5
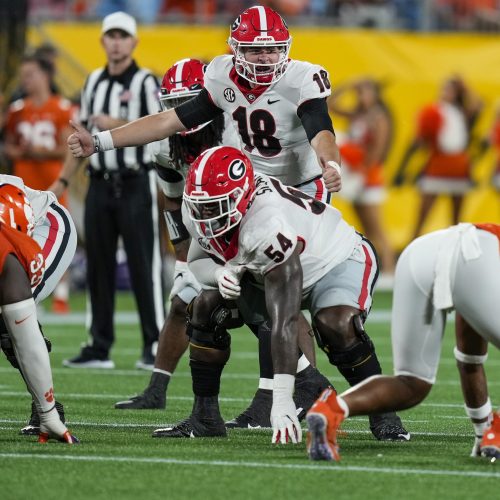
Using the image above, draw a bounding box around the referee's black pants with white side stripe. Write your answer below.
[84,170,165,358]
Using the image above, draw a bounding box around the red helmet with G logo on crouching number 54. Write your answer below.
[183,146,255,238]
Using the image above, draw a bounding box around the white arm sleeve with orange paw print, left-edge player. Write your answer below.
[2,298,55,413]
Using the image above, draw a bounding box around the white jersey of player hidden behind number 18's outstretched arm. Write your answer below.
[147,116,242,198]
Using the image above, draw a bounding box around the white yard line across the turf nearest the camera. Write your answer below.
[0,453,500,479]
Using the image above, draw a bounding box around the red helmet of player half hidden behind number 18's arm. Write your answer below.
[159,59,210,135]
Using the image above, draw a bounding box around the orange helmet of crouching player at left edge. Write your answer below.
[0,184,35,236]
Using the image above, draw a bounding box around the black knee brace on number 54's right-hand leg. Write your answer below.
[313,314,375,368]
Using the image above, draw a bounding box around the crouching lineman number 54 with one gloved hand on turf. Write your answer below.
[145,146,406,443]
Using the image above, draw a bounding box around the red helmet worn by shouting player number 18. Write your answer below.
[228,6,292,85]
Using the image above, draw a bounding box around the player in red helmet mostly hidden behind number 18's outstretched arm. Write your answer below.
[115,59,329,430]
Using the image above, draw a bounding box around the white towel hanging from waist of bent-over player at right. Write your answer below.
[433,223,482,309]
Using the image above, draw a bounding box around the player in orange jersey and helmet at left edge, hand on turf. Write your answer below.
[0,184,77,444]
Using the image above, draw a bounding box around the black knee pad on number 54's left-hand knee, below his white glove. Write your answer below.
[187,303,232,351]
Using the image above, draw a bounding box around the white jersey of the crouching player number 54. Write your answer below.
[182,174,361,289]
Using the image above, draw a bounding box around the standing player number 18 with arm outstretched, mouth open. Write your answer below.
[68,6,406,439]
